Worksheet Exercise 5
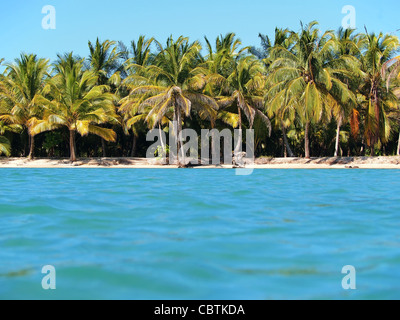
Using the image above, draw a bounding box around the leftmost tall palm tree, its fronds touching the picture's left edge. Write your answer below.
[0,54,49,159]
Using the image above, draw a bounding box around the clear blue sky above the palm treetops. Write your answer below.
[0,0,400,61]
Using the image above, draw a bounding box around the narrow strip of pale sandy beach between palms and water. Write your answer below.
[0,156,400,169]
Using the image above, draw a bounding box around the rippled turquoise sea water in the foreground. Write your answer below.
[0,169,400,299]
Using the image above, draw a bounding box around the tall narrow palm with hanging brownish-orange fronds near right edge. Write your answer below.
[360,31,399,155]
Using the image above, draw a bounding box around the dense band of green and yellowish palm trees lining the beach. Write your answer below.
[0,22,400,161]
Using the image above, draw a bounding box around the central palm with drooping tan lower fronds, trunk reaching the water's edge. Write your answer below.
[126,36,218,164]
